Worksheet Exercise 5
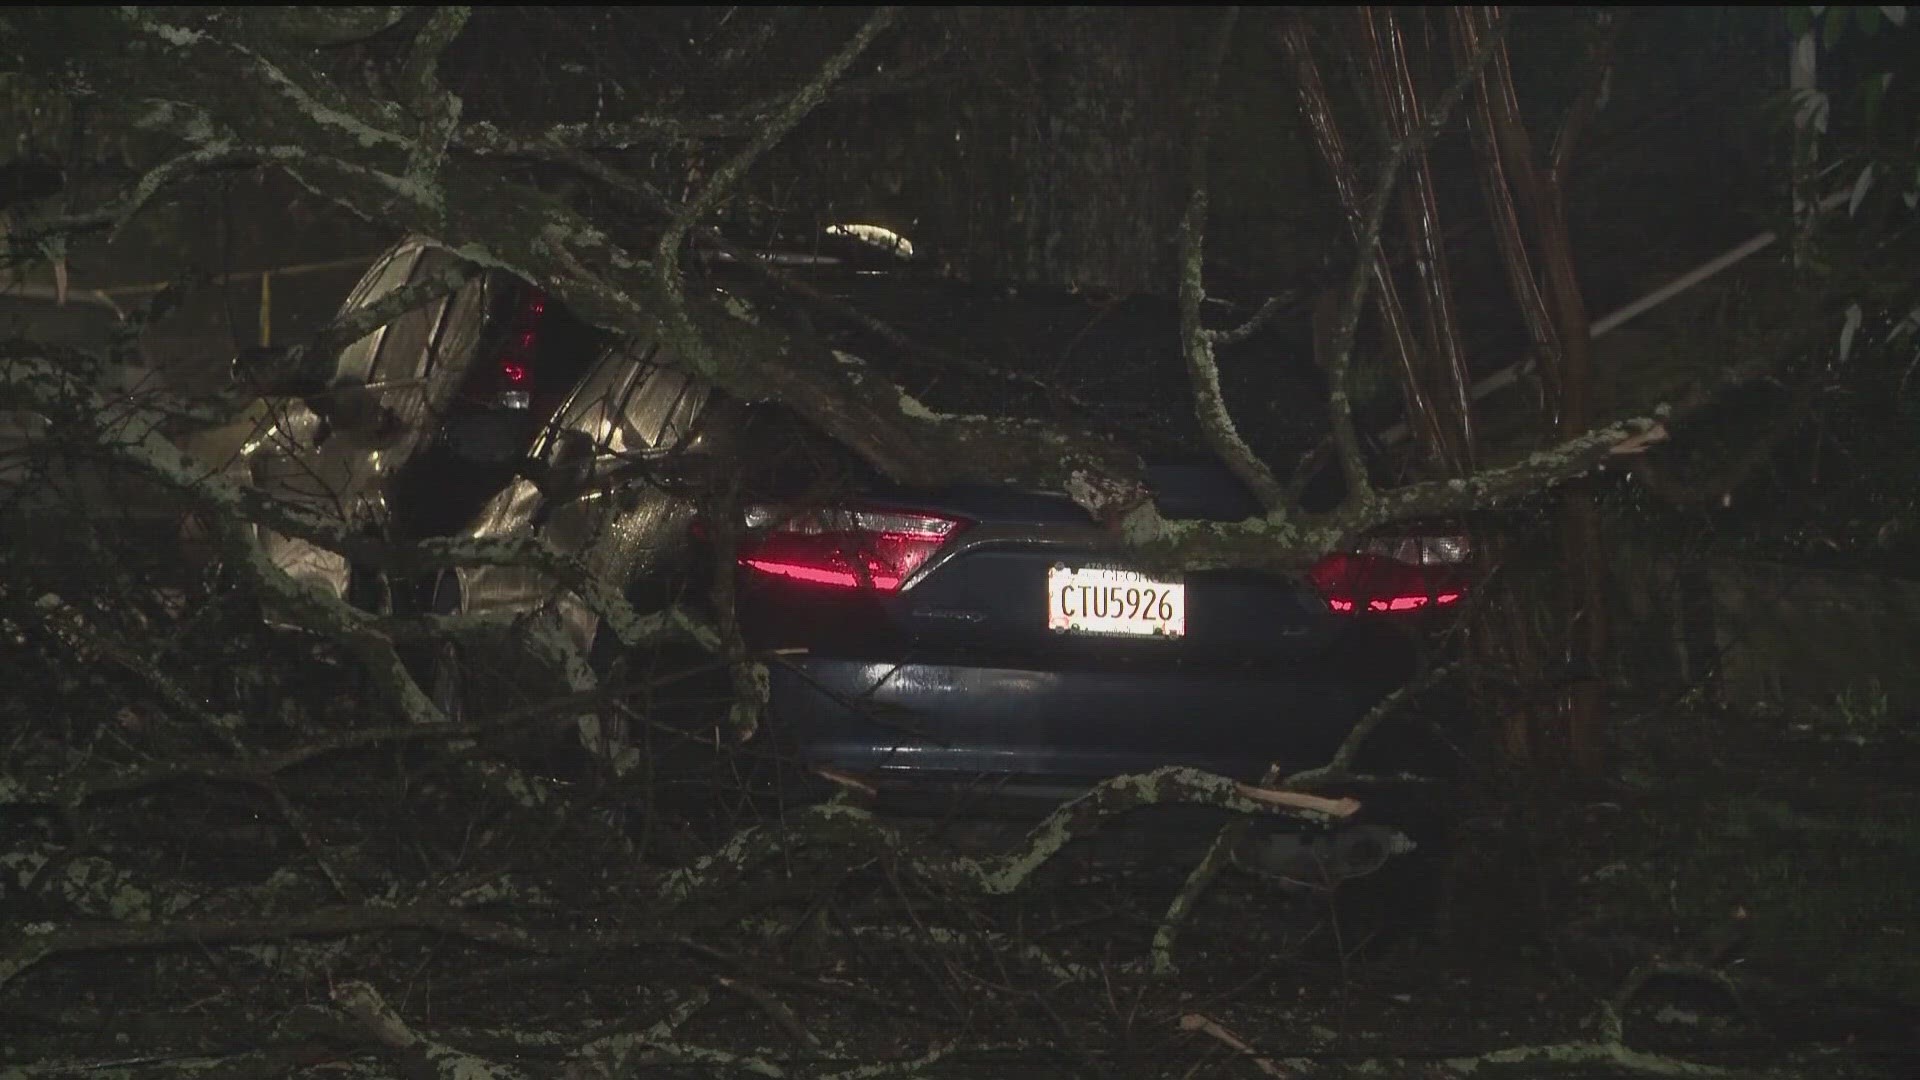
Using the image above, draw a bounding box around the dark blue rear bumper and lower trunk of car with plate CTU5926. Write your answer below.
[739,515,1425,778]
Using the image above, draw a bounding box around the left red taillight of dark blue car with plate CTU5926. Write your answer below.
[739,505,966,592]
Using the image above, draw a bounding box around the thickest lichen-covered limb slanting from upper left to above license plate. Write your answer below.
[41,13,1146,521]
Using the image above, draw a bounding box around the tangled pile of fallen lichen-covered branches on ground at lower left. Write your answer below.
[0,372,1758,1078]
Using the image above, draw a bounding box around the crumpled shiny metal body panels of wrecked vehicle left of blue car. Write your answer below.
[244,240,707,638]
